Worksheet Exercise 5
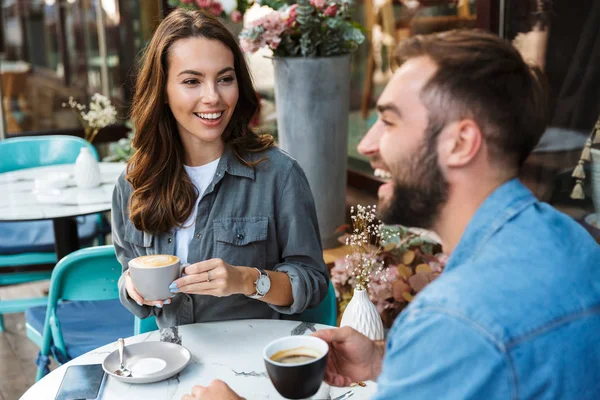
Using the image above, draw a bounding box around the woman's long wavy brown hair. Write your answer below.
[127,9,273,234]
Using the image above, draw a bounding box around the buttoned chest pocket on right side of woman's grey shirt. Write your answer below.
[213,217,269,268]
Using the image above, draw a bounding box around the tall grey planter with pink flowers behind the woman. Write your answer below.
[240,0,364,247]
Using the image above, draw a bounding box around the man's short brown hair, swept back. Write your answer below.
[396,29,548,169]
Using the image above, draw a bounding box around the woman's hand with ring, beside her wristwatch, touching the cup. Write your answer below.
[170,258,253,297]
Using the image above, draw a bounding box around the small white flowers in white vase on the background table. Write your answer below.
[62,93,117,143]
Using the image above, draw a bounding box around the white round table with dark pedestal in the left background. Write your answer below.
[0,162,125,260]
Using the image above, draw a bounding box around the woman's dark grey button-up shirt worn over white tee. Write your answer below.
[112,146,329,328]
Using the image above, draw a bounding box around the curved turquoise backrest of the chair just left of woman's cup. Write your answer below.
[48,246,122,308]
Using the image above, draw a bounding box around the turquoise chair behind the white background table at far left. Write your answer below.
[0,135,108,332]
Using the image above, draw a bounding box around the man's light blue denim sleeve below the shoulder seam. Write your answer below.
[374,309,515,400]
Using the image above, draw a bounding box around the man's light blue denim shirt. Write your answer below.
[375,179,600,400]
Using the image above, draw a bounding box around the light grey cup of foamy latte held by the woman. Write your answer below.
[129,254,187,301]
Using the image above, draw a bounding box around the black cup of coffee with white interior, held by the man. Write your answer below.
[263,336,329,399]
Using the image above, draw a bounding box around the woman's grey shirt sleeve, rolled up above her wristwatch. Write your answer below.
[270,162,329,314]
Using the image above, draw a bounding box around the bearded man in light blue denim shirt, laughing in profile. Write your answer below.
[182,31,600,400]
